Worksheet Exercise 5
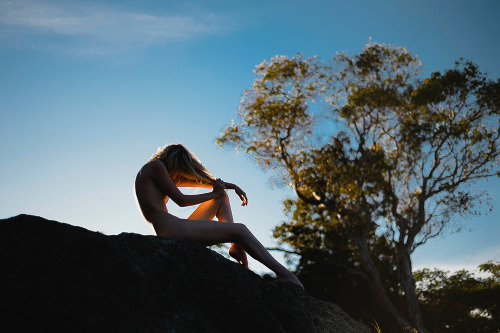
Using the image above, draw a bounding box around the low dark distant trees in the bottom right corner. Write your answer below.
[414,261,500,333]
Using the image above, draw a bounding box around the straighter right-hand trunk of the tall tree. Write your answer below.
[397,244,427,333]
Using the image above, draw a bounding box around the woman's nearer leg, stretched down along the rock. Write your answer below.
[153,213,303,288]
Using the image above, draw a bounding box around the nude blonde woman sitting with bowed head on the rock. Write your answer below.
[135,144,303,288]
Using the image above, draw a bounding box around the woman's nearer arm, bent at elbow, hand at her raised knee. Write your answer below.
[148,161,224,207]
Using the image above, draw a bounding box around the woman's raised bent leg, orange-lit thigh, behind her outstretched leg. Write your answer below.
[188,194,248,268]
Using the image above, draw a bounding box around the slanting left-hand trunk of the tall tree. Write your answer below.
[353,237,412,331]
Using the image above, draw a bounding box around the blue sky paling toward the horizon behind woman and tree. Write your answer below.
[0,0,500,273]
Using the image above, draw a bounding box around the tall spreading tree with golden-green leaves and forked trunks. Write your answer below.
[217,43,500,332]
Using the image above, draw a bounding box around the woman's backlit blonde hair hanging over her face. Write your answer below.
[148,144,215,184]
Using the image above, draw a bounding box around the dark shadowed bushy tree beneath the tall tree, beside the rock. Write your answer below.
[275,202,403,332]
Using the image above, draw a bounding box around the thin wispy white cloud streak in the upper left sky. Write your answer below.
[0,0,225,54]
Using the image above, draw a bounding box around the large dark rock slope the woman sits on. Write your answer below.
[0,215,369,333]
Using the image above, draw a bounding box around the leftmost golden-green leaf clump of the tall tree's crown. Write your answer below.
[217,55,322,168]
